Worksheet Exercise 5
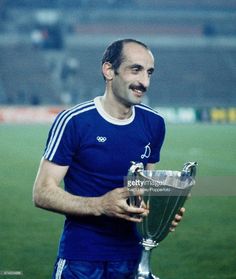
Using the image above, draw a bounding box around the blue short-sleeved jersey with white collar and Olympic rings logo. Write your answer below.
[44,97,165,261]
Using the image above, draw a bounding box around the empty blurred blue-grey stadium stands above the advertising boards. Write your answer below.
[0,0,236,122]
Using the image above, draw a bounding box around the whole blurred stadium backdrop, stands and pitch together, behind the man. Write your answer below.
[0,0,236,279]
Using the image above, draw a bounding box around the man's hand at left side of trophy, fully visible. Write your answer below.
[99,188,149,222]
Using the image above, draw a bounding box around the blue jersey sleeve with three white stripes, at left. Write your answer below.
[43,112,79,166]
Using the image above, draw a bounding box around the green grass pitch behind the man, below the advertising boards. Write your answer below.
[0,124,236,279]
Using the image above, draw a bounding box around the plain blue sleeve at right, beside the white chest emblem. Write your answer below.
[148,116,165,164]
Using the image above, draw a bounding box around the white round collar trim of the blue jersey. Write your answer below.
[94,96,135,125]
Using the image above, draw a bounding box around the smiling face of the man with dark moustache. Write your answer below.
[112,43,154,106]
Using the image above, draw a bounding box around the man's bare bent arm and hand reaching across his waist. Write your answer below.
[33,160,148,222]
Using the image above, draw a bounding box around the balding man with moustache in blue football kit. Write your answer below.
[33,39,183,279]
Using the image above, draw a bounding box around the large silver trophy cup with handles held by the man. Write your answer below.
[127,162,197,279]
